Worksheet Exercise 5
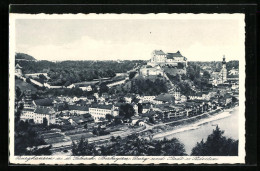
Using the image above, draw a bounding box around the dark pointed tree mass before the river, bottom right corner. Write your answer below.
[191,126,238,156]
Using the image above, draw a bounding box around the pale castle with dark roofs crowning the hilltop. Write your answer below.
[147,50,187,67]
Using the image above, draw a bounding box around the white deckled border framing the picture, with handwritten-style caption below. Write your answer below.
[9,13,245,165]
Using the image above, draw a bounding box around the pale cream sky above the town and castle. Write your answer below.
[15,15,245,61]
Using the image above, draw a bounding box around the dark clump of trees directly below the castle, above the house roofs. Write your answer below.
[129,78,168,96]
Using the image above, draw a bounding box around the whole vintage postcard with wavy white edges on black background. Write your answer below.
[9,13,245,165]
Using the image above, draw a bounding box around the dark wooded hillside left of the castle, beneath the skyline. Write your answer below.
[16,57,144,86]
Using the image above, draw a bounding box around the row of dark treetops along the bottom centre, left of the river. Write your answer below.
[72,134,186,156]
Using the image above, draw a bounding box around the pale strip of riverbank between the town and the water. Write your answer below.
[152,106,239,140]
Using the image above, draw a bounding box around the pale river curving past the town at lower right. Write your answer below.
[160,107,239,155]
